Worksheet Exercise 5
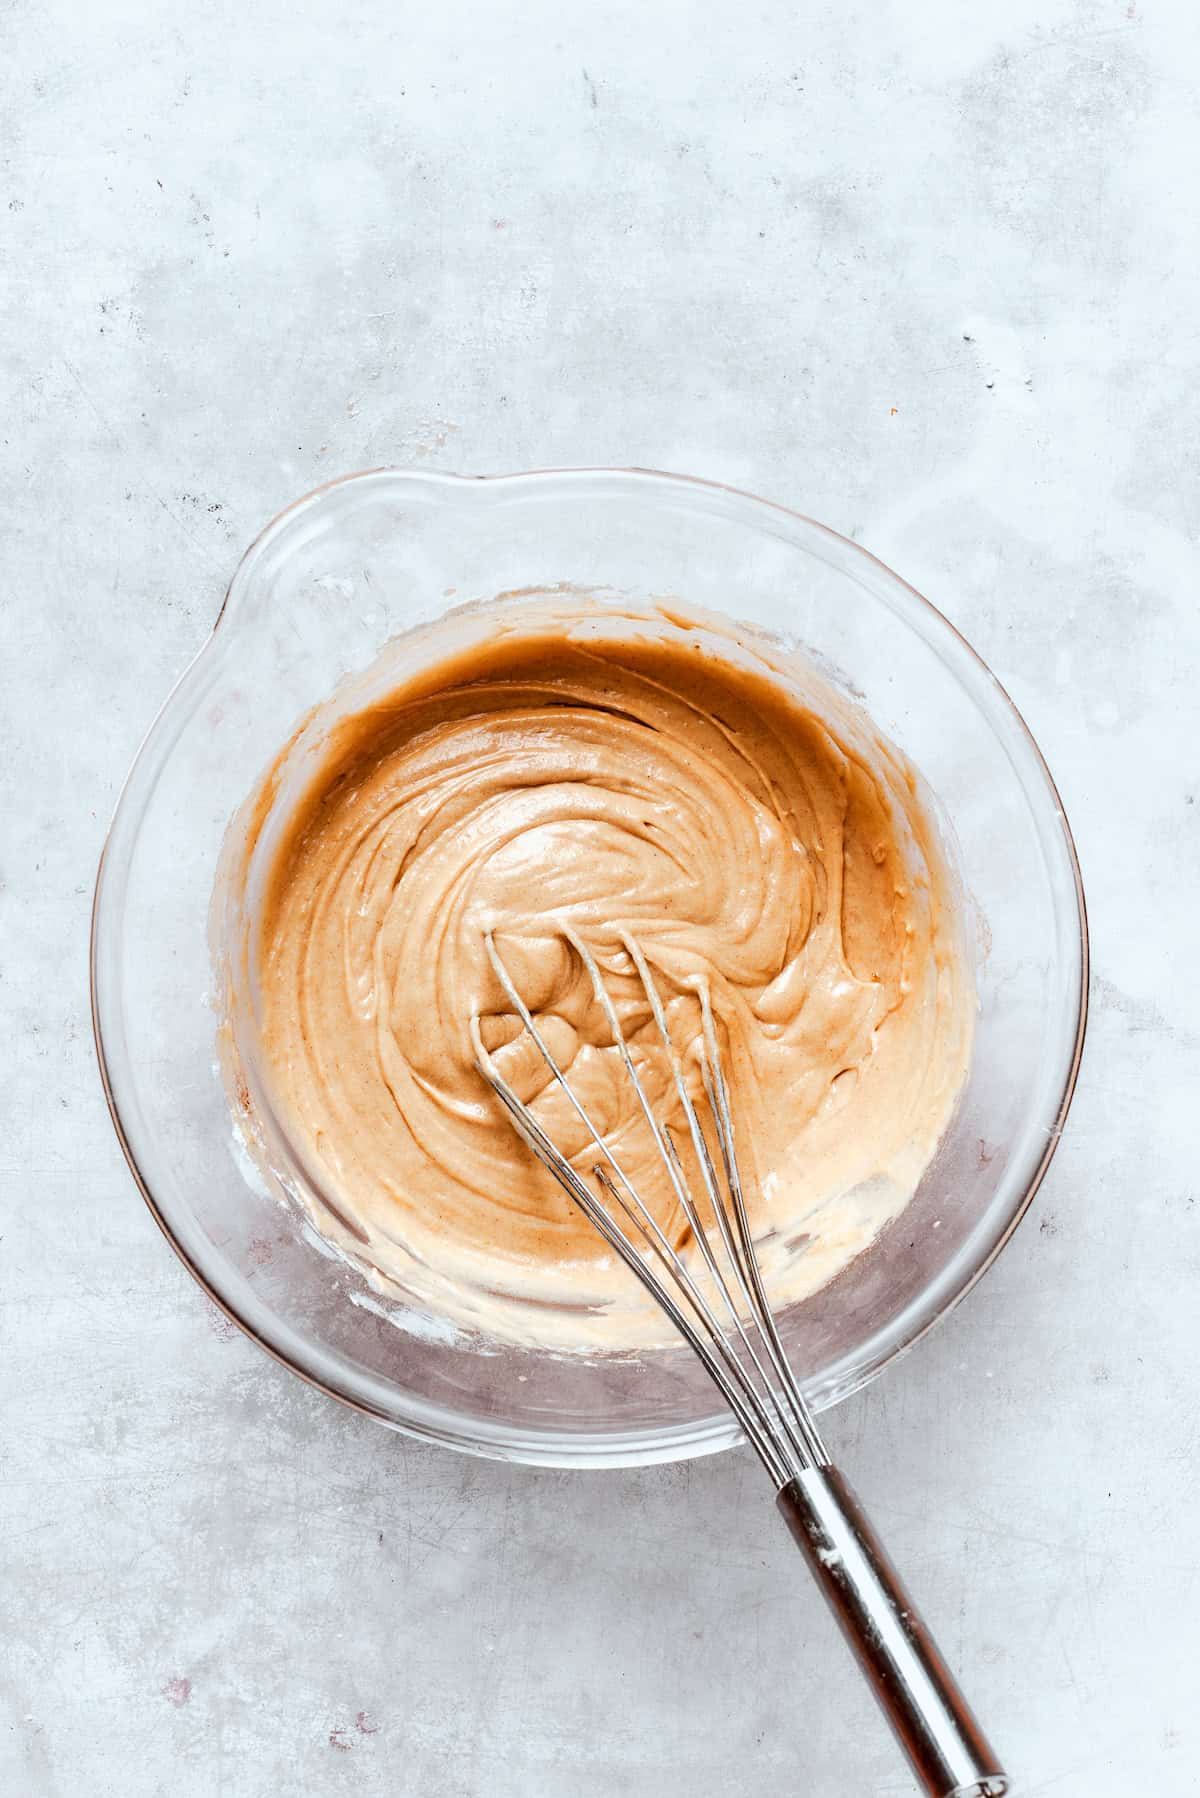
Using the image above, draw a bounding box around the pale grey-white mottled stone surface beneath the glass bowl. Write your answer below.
[0,0,1200,1798]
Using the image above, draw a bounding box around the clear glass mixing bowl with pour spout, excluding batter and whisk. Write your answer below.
[92,469,1087,1467]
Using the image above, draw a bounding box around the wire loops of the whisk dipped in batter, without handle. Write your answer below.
[471,928,829,1489]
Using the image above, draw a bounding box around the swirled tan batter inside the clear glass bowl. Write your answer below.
[218,601,973,1349]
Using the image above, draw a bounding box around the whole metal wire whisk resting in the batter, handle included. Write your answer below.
[470,928,1009,1798]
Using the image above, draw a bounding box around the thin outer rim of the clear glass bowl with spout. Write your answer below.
[88,464,1090,1469]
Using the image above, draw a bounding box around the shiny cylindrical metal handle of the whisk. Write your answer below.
[775,1467,1007,1798]
